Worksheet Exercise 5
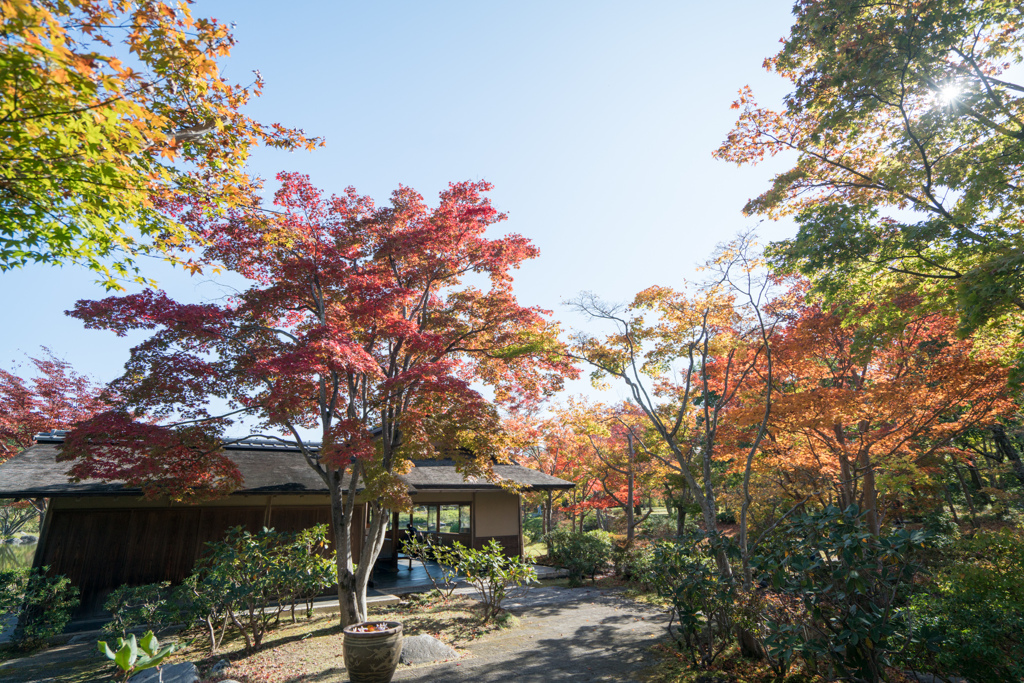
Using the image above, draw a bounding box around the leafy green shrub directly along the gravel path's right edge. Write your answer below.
[650,531,737,669]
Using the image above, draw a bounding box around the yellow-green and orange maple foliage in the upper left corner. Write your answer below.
[0,0,318,289]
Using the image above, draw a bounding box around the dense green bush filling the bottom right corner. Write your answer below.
[909,529,1024,683]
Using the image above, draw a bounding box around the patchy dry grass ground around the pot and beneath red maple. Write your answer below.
[0,596,514,683]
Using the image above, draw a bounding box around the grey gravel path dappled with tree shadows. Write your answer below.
[394,588,667,683]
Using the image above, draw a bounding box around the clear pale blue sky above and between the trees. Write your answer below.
[0,0,794,411]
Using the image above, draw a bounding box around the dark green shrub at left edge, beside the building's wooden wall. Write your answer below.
[0,567,79,650]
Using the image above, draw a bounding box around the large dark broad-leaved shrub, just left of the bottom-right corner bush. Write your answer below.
[755,506,928,682]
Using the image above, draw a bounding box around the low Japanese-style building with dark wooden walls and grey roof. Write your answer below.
[0,432,573,616]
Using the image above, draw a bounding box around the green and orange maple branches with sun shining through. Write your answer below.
[716,0,1024,333]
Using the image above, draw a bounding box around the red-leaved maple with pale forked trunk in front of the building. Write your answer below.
[65,173,574,625]
